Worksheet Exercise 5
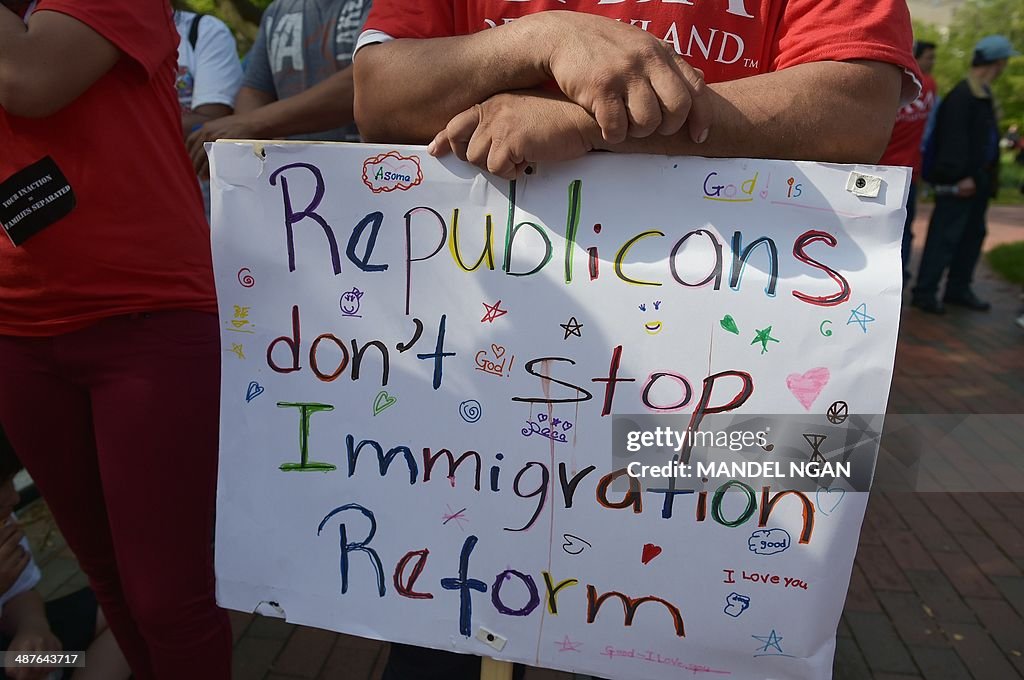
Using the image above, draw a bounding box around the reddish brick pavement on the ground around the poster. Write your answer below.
[23,206,1024,680]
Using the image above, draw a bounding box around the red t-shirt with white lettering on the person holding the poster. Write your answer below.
[364,0,919,102]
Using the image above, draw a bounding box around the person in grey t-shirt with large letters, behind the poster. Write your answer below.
[188,0,371,176]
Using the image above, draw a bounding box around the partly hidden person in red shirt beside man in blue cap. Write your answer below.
[879,40,938,286]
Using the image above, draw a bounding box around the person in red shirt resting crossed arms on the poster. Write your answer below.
[353,0,920,680]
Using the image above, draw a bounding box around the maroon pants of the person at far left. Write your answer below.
[0,311,231,680]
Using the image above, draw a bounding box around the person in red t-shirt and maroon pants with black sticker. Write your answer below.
[0,0,231,680]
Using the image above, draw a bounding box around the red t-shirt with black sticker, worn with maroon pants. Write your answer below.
[0,0,216,336]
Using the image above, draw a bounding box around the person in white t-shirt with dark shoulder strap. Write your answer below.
[171,0,242,219]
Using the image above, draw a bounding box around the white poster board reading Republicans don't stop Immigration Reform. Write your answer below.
[211,142,909,679]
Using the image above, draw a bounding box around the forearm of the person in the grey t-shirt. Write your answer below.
[240,67,353,139]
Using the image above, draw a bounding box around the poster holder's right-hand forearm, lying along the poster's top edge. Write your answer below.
[595,61,901,163]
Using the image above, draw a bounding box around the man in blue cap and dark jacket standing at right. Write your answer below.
[911,36,1018,314]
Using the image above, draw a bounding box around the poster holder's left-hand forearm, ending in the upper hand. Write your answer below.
[354,20,548,143]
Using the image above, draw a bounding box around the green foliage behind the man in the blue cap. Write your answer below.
[913,0,1024,129]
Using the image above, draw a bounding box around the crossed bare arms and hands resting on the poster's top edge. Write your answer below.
[355,11,902,177]
